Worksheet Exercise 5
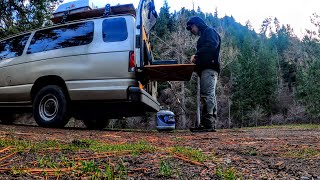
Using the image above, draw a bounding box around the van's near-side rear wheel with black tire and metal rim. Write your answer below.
[33,85,70,128]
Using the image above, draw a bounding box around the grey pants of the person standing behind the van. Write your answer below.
[200,69,218,128]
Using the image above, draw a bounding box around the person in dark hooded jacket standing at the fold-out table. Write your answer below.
[186,17,221,132]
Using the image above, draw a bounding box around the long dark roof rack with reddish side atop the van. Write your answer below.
[51,4,136,24]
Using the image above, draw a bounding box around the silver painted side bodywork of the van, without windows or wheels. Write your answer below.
[0,15,159,110]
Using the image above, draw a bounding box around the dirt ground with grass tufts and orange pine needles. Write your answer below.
[0,125,320,179]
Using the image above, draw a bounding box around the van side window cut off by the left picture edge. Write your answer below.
[0,33,30,60]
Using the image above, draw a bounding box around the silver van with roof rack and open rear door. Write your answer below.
[0,0,160,129]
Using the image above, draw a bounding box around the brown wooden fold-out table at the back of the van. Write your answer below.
[144,64,195,81]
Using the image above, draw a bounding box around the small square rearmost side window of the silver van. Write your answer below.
[102,18,128,42]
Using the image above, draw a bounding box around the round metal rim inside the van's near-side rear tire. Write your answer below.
[39,94,59,121]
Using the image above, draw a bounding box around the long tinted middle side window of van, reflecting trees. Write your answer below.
[27,21,94,54]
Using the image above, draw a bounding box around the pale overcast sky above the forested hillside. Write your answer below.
[64,0,320,36]
